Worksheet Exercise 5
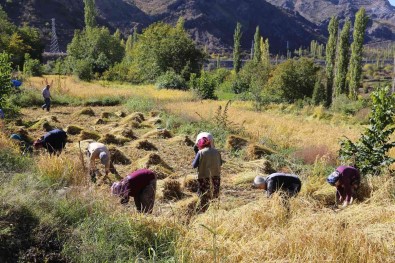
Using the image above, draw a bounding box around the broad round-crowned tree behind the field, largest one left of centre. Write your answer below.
[132,22,205,82]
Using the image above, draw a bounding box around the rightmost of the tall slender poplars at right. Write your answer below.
[349,8,369,99]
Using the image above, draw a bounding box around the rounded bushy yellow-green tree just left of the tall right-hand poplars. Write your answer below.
[266,57,319,103]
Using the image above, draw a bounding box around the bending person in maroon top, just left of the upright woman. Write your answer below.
[111,169,156,214]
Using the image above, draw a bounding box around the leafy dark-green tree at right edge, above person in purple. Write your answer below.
[339,87,395,174]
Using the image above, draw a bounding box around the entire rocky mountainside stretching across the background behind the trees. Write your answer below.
[0,0,395,53]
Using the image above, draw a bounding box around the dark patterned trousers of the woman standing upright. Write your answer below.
[198,176,221,212]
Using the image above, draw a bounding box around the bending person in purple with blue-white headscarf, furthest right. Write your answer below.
[327,165,361,208]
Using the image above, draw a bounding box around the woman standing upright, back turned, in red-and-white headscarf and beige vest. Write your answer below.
[192,137,222,212]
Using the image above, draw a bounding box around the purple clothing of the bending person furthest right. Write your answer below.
[336,165,361,202]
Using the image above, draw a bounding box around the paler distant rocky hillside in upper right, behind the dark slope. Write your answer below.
[266,0,395,41]
